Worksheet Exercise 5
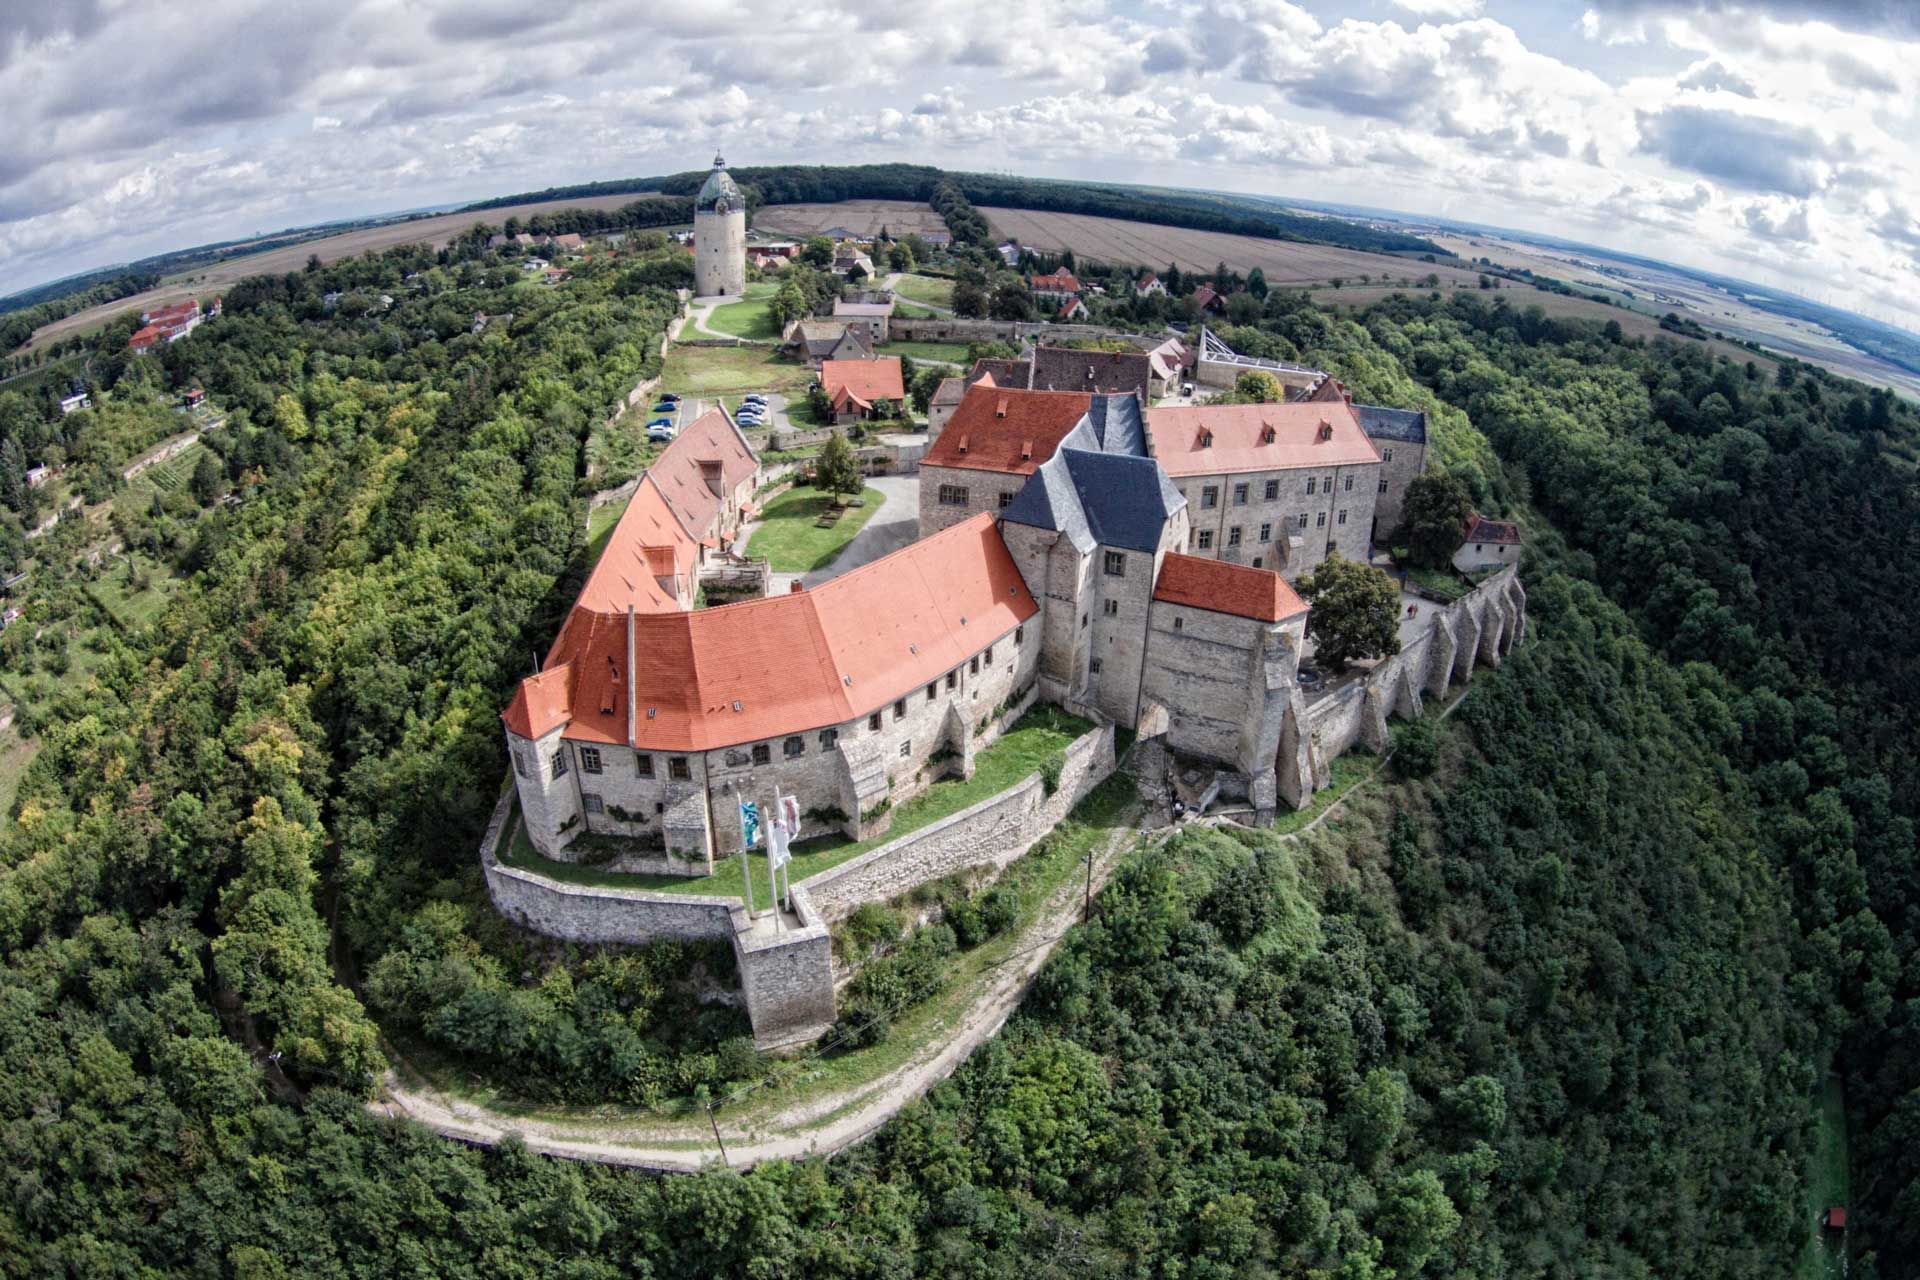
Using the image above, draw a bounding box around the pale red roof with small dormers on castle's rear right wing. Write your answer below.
[1144,401,1380,476]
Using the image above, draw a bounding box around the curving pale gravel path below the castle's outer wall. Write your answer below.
[382,812,1139,1173]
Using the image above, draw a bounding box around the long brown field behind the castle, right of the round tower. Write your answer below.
[981,209,1480,284]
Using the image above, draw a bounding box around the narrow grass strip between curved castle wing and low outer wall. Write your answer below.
[499,706,1092,906]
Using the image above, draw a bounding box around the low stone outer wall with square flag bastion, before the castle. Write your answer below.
[480,712,1114,1050]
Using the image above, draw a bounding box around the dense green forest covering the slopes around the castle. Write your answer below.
[0,238,1920,1280]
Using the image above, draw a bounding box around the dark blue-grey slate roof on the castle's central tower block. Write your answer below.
[1000,445,1187,553]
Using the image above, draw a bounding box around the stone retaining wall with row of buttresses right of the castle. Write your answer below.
[1275,566,1526,808]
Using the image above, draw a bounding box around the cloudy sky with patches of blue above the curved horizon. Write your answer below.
[0,0,1920,328]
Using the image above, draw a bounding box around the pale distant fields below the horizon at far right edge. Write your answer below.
[1430,234,1920,395]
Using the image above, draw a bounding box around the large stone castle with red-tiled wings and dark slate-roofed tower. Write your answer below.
[503,372,1517,875]
